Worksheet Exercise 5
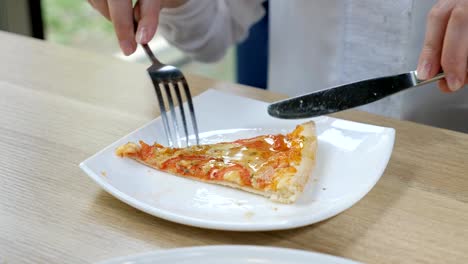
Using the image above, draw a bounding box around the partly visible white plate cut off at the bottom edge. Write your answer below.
[100,246,358,264]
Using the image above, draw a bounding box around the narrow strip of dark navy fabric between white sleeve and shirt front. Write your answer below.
[236,1,268,89]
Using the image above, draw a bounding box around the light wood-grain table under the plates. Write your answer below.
[0,32,468,263]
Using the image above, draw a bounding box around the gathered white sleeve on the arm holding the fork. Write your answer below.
[158,0,265,62]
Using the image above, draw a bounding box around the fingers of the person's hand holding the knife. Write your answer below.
[417,0,468,92]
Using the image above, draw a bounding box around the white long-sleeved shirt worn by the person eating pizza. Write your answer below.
[159,0,468,130]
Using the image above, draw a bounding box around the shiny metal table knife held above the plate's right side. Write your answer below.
[268,71,445,119]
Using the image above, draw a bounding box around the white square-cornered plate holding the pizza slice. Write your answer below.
[80,90,395,231]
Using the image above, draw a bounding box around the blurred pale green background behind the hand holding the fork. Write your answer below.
[42,0,235,82]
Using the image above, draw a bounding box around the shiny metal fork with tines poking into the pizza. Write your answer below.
[138,44,200,147]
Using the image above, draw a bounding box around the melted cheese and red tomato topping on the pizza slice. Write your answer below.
[117,124,304,189]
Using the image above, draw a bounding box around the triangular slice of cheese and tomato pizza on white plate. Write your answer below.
[116,121,317,203]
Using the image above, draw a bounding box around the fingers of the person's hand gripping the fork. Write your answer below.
[88,0,187,55]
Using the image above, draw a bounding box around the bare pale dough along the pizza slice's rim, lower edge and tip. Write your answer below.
[116,121,317,203]
